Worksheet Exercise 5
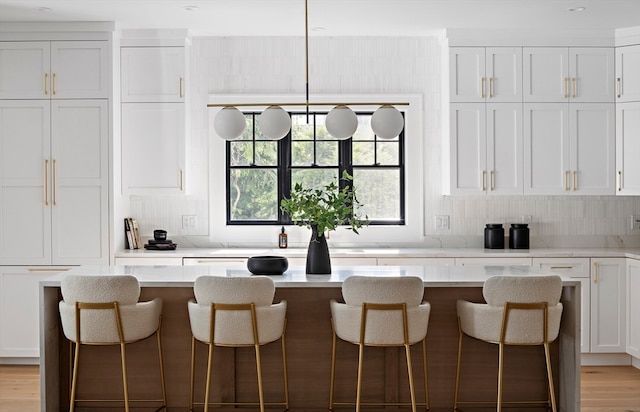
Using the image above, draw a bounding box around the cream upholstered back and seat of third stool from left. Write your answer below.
[330,275,431,346]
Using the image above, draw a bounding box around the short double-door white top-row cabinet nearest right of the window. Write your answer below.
[449,47,522,103]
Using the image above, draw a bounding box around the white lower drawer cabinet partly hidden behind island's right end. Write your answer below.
[533,258,591,353]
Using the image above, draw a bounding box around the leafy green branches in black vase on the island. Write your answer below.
[280,171,368,274]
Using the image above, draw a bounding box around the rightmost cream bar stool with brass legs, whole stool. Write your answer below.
[454,276,562,412]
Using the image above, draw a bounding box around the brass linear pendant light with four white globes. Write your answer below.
[207,0,409,140]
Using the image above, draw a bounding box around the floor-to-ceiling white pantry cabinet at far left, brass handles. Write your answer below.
[0,30,112,362]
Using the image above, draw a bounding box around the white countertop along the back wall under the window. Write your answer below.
[115,245,640,259]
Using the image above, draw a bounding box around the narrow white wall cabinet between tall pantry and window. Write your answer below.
[120,40,188,195]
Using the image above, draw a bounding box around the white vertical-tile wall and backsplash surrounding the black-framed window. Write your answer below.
[131,37,640,247]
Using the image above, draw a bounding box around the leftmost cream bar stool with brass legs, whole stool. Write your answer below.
[59,274,167,412]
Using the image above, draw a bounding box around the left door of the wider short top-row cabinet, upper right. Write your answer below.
[522,47,570,102]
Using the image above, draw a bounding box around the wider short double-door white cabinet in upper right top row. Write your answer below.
[523,47,614,102]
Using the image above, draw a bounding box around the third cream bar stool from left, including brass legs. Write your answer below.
[329,275,431,412]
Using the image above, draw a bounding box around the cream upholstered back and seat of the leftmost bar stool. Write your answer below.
[59,274,162,344]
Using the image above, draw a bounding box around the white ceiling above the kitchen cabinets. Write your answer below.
[0,0,640,36]
